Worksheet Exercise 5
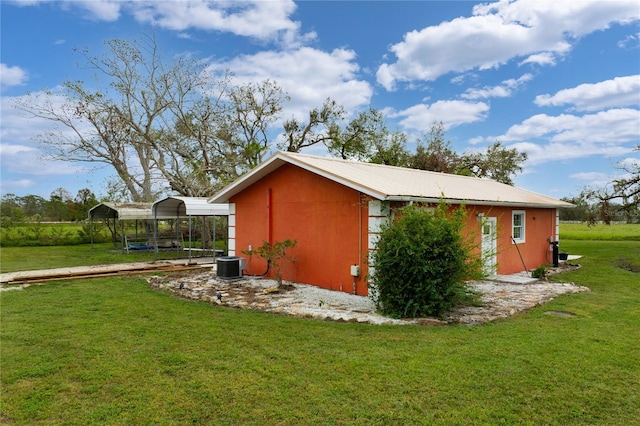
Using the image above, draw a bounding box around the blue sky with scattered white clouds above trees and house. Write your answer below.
[0,0,640,198]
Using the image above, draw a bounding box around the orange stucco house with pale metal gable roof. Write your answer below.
[209,152,572,295]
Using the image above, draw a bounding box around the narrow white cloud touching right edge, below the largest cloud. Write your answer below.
[534,74,640,111]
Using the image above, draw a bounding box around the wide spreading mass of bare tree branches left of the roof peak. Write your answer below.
[17,36,284,201]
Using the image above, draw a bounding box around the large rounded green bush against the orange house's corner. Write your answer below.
[372,202,482,318]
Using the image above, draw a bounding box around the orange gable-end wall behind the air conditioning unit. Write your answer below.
[230,164,368,295]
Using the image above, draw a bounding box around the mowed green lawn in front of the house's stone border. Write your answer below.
[0,226,640,425]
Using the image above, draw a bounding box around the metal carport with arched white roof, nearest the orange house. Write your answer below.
[151,196,229,259]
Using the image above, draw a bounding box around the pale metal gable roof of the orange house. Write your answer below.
[209,152,574,208]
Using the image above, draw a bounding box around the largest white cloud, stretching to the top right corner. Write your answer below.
[377,0,639,90]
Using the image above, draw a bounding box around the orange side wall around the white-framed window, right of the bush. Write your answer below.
[468,206,558,275]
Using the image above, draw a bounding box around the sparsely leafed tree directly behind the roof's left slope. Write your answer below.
[163,80,287,196]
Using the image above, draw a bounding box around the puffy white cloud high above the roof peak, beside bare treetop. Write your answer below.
[210,47,373,119]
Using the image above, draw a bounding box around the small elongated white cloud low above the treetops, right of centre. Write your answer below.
[388,100,489,132]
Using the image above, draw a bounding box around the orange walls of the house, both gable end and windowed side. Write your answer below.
[229,164,557,295]
